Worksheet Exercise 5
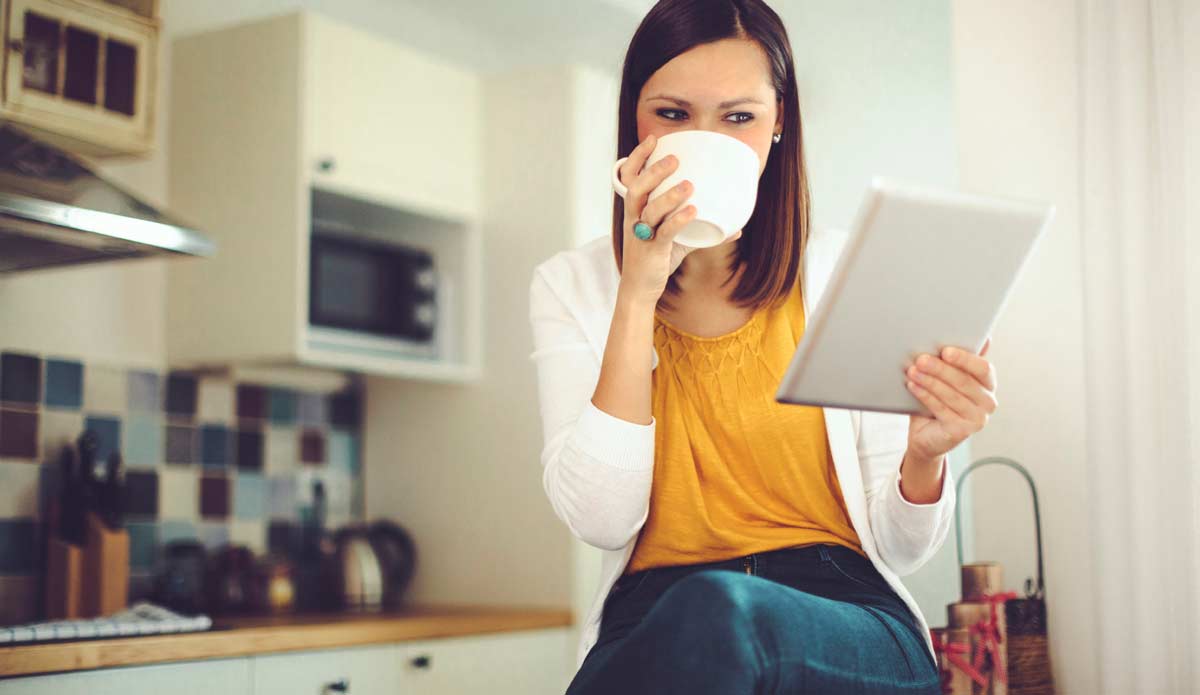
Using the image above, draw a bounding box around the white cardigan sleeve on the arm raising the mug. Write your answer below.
[529,266,655,550]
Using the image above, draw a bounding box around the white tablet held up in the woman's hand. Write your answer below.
[775,178,1055,417]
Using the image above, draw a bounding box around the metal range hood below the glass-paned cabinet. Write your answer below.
[0,124,216,274]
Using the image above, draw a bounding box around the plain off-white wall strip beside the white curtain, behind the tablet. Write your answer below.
[954,0,1099,695]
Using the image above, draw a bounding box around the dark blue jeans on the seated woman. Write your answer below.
[566,545,941,695]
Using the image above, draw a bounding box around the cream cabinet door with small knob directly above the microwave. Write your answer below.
[305,16,482,217]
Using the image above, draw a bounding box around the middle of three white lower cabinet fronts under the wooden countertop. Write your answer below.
[253,645,412,695]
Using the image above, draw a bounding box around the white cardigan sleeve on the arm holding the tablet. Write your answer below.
[858,411,955,576]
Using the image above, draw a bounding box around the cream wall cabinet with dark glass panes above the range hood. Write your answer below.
[0,0,158,156]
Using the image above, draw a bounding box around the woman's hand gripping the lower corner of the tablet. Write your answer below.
[905,337,997,461]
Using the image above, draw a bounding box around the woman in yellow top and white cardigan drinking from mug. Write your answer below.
[529,0,996,695]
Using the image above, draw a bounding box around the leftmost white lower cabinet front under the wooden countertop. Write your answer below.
[0,658,253,695]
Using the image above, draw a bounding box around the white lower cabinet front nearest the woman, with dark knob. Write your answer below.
[401,628,572,695]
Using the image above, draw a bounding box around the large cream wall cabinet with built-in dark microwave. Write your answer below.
[167,12,482,381]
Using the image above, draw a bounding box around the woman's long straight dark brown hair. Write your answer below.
[612,0,810,310]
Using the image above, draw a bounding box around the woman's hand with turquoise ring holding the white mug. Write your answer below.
[619,134,696,305]
